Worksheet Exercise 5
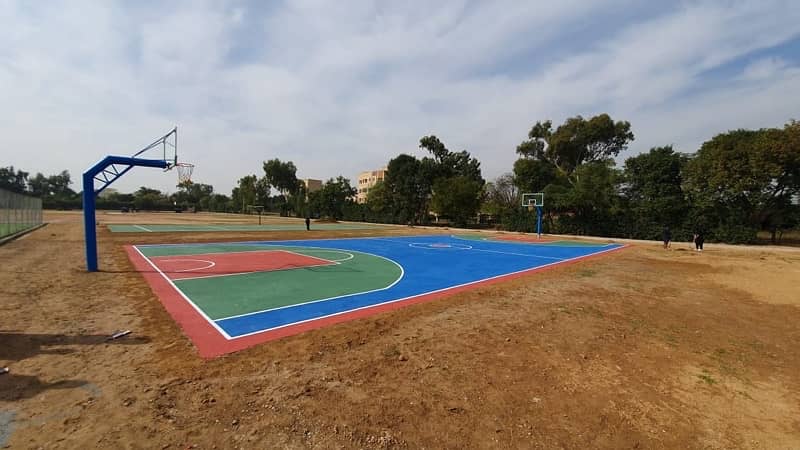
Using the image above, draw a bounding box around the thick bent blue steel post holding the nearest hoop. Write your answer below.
[83,156,169,272]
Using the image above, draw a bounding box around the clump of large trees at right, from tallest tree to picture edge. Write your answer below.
[494,114,800,243]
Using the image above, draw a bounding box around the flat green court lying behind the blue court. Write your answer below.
[108,222,380,233]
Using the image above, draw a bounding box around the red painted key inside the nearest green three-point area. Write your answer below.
[150,250,335,280]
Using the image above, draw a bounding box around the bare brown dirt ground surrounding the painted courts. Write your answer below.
[0,212,800,449]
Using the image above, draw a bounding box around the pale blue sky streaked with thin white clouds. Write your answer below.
[0,0,800,195]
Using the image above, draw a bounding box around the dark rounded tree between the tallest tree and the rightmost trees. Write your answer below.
[623,146,690,239]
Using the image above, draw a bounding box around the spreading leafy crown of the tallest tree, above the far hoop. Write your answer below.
[517,114,634,183]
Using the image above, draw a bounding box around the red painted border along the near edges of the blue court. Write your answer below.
[125,244,628,359]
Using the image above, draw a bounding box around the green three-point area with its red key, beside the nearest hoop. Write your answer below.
[140,244,403,320]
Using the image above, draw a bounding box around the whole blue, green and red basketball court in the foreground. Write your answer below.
[129,235,623,355]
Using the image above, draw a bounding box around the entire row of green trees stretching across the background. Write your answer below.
[0,114,800,243]
